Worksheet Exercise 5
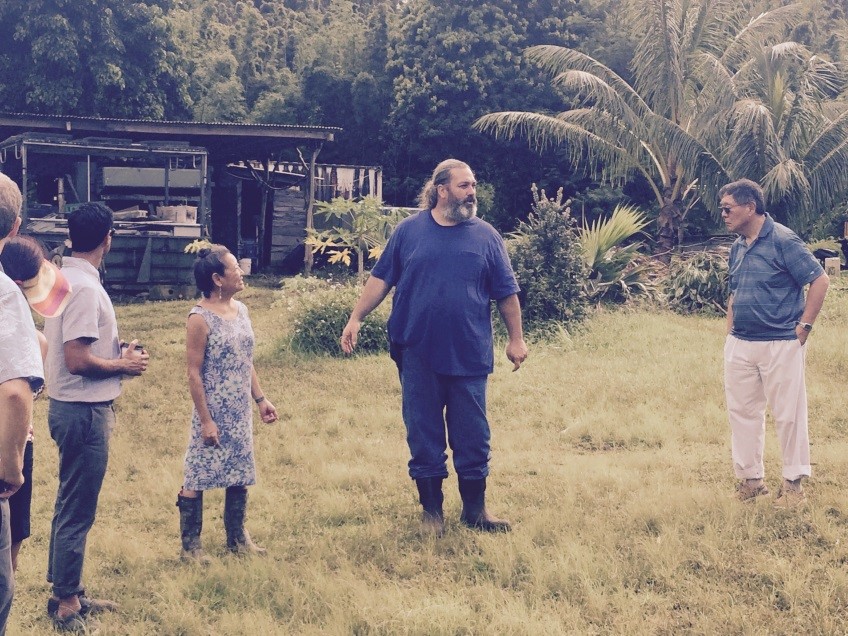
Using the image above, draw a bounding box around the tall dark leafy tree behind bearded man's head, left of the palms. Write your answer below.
[382,0,608,216]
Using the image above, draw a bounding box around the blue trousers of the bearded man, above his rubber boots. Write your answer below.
[396,350,491,479]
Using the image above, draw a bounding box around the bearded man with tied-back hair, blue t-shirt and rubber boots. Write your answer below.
[341,159,527,536]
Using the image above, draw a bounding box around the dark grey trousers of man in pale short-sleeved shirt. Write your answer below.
[47,399,115,598]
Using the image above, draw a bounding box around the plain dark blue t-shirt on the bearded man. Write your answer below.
[371,210,518,376]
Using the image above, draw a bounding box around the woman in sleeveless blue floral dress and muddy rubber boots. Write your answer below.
[177,245,277,562]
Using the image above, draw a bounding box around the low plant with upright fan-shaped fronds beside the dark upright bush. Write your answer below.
[580,204,652,301]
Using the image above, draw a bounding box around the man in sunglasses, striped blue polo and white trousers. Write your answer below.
[719,179,829,508]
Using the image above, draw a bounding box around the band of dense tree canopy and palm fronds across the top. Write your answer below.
[0,0,848,236]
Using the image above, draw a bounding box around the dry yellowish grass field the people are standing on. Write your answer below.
[9,281,848,635]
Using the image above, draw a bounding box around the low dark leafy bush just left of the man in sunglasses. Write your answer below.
[665,252,729,314]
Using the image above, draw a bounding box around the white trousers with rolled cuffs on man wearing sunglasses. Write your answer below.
[724,336,811,479]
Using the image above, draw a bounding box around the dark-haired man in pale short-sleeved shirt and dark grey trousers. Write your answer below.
[44,202,148,628]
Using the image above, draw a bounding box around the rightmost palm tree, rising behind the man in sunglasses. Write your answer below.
[720,42,848,227]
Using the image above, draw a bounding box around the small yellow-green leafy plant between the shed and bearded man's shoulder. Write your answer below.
[306,196,407,283]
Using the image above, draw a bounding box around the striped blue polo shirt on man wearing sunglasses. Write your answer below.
[729,215,824,341]
